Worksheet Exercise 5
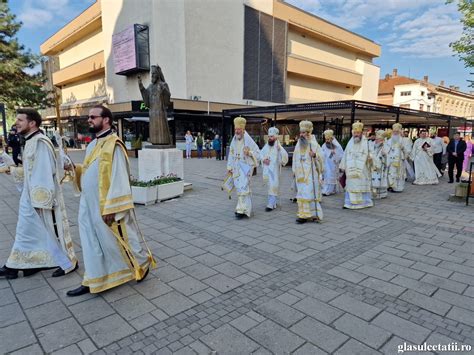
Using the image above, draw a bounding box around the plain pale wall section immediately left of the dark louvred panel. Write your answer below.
[183,0,244,104]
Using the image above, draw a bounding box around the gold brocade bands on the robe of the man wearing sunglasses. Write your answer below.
[75,134,156,280]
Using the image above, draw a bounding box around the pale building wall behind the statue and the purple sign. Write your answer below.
[101,0,187,103]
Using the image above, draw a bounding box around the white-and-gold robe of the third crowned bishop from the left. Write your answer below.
[292,135,324,220]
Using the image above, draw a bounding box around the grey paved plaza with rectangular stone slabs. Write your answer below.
[0,152,474,355]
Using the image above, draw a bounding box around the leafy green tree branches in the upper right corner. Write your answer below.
[447,0,474,87]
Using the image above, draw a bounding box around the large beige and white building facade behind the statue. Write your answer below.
[41,0,380,145]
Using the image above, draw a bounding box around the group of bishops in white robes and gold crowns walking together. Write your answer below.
[223,117,441,223]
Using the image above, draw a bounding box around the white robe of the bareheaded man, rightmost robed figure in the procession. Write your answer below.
[410,138,441,185]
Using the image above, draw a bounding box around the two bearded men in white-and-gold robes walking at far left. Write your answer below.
[0,105,155,297]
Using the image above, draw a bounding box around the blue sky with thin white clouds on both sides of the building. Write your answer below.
[9,0,473,91]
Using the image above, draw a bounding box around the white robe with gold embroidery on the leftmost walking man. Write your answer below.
[6,133,77,273]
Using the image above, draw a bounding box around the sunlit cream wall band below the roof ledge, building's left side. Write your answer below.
[58,29,104,69]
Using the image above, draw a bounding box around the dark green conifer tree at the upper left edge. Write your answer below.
[0,0,51,114]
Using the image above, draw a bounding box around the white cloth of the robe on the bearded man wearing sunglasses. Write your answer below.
[78,138,151,293]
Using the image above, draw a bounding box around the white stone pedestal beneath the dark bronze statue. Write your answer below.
[138,146,184,181]
